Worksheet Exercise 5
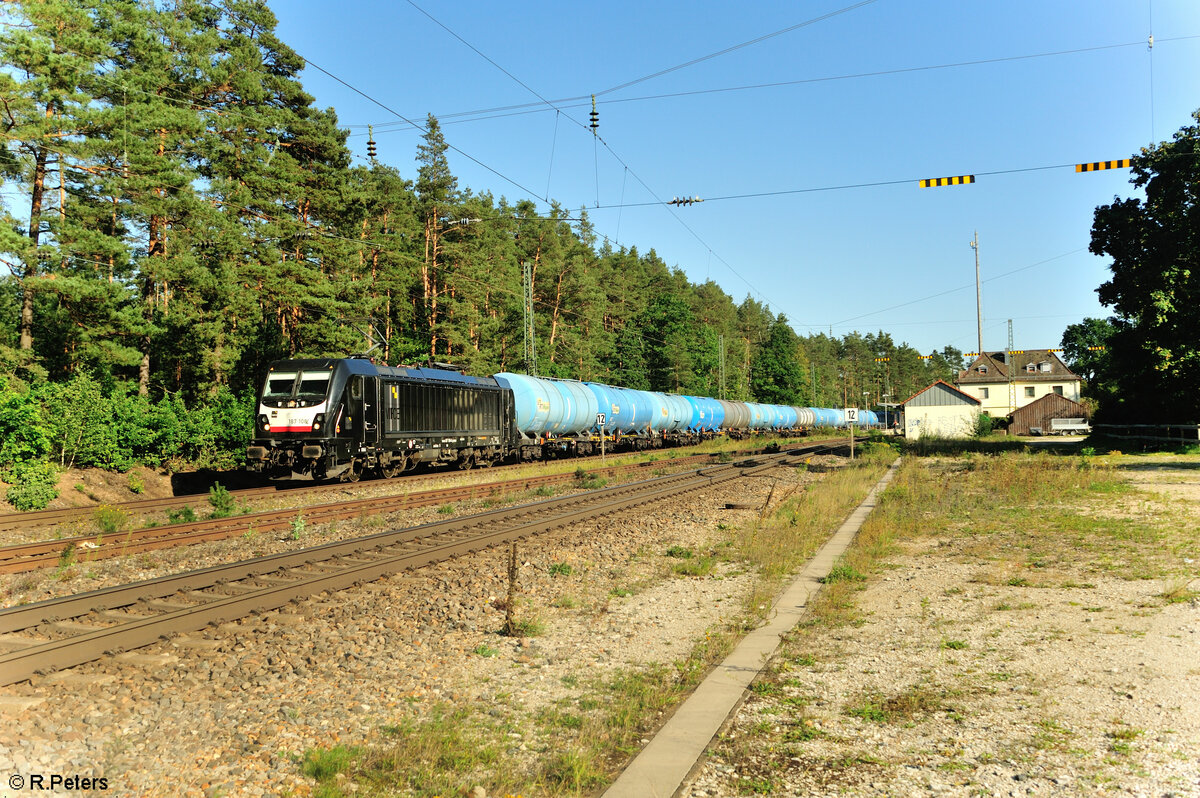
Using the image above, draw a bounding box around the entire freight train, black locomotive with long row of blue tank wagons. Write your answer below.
[246,358,878,482]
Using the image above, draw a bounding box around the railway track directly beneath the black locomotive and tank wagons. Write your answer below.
[0,450,787,533]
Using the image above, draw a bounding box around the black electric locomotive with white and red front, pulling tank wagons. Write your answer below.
[246,358,518,482]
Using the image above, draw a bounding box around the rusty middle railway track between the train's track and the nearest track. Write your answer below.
[0,455,777,574]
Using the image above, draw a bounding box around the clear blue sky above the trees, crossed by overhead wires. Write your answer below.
[274,0,1200,353]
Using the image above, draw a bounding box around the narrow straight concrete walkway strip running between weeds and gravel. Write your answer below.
[604,460,900,798]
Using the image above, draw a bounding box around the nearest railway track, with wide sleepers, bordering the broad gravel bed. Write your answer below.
[0,445,828,685]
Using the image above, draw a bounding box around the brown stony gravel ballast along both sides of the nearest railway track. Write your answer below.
[0,458,815,796]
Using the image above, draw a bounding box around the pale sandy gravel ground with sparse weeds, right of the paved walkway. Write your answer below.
[682,458,1200,798]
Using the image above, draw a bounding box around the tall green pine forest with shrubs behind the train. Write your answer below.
[0,0,961,460]
